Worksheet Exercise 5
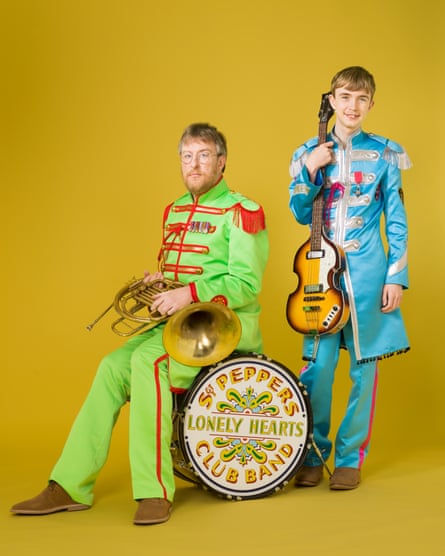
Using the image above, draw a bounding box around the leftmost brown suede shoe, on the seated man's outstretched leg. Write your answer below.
[10,481,90,515]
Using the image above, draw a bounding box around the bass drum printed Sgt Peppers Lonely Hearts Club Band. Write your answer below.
[172,354,312,500]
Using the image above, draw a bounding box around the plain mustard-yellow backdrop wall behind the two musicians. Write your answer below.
[0,0,445,480]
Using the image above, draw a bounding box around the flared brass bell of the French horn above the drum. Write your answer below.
[162,302,241,367]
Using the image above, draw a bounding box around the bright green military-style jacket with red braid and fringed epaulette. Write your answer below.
[159,179,269,353]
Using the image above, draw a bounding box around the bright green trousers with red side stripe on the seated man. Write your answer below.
[50,325,200,505]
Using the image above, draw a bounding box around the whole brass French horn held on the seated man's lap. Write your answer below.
[87,278,241,367]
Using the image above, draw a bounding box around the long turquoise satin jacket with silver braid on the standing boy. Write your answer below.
[289,129,411,361]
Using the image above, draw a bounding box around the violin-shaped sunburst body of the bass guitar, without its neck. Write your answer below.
[286,233,349,336]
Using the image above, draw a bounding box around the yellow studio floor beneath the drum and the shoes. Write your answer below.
[0,450,445,556]
